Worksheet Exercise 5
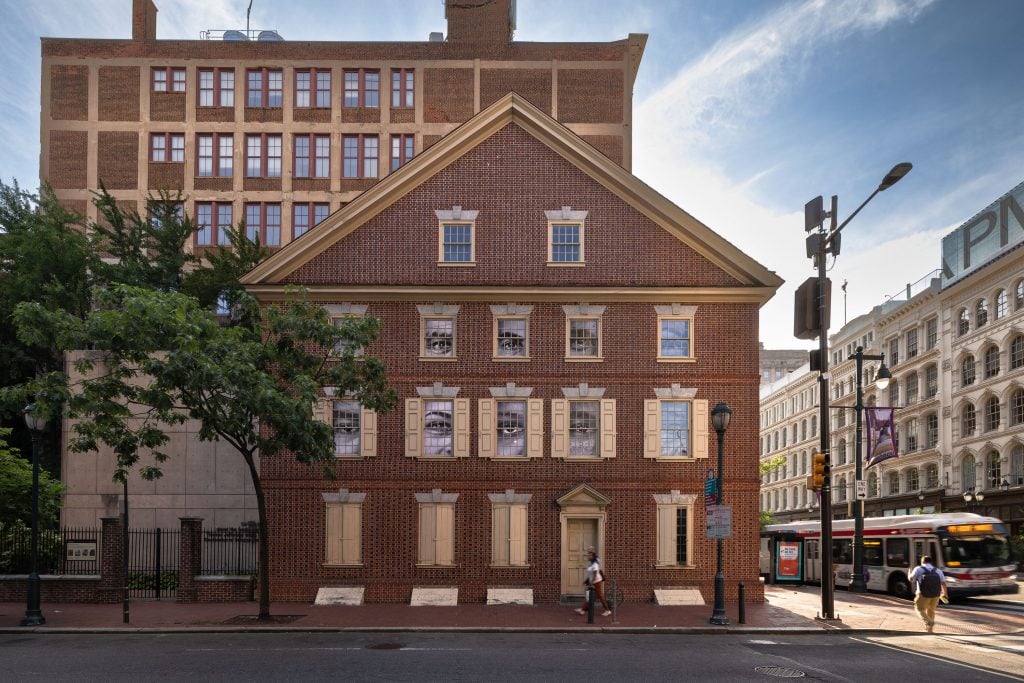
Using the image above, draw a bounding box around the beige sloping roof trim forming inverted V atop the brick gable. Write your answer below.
[242,93,782,296]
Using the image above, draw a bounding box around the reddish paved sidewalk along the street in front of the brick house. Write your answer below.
[0,586,1024,634]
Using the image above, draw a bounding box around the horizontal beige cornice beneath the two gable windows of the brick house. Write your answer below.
[246,285,775,304]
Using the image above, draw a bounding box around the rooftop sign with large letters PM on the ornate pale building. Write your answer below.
[942,182,1024,288]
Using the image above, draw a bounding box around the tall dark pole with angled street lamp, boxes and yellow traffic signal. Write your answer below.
[797,162,913,621]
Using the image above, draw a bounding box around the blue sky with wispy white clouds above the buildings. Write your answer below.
[0,0,1024,348]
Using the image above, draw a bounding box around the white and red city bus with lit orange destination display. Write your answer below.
[761,512,1018,598]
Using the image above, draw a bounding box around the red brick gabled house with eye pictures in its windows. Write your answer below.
[245,93,781,602]
